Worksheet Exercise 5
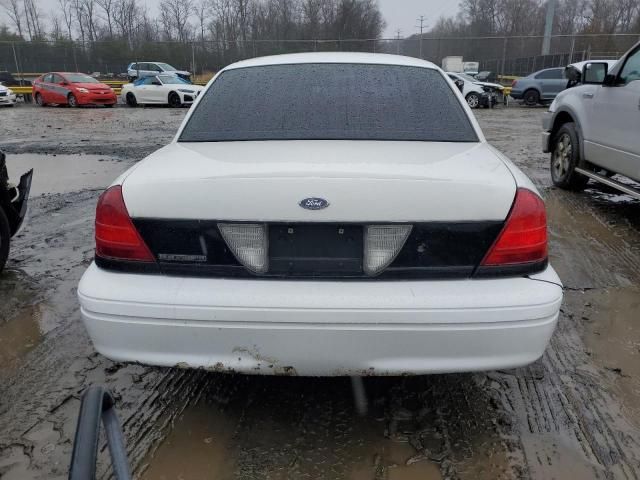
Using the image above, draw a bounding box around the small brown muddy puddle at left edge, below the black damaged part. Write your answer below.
[0,304,46,367]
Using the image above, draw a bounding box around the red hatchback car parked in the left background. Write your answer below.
[33,72,118,107]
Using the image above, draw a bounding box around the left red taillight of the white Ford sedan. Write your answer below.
[96,185,155,262]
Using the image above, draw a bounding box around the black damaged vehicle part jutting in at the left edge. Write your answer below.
[0,152,33,271]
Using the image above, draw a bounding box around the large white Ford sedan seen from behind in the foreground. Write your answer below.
[78,53,562,376]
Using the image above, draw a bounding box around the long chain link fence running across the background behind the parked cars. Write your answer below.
[0,34,640,80]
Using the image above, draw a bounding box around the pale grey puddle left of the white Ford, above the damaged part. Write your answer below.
[7,154,130,197]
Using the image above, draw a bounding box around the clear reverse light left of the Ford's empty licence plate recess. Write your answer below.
[218,223,269,273]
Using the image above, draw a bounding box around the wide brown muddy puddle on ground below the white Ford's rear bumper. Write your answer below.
[141,390,442,480]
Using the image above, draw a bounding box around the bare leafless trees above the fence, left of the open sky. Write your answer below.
[0,0,384,47]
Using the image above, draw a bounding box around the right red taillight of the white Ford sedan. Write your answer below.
[481,188,548,267]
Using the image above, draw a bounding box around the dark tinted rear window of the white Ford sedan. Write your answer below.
[180,64,478,142]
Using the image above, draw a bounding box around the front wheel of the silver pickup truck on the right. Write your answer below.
[551,122,589,191]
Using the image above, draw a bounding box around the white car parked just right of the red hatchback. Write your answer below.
[120,74,204,107]
